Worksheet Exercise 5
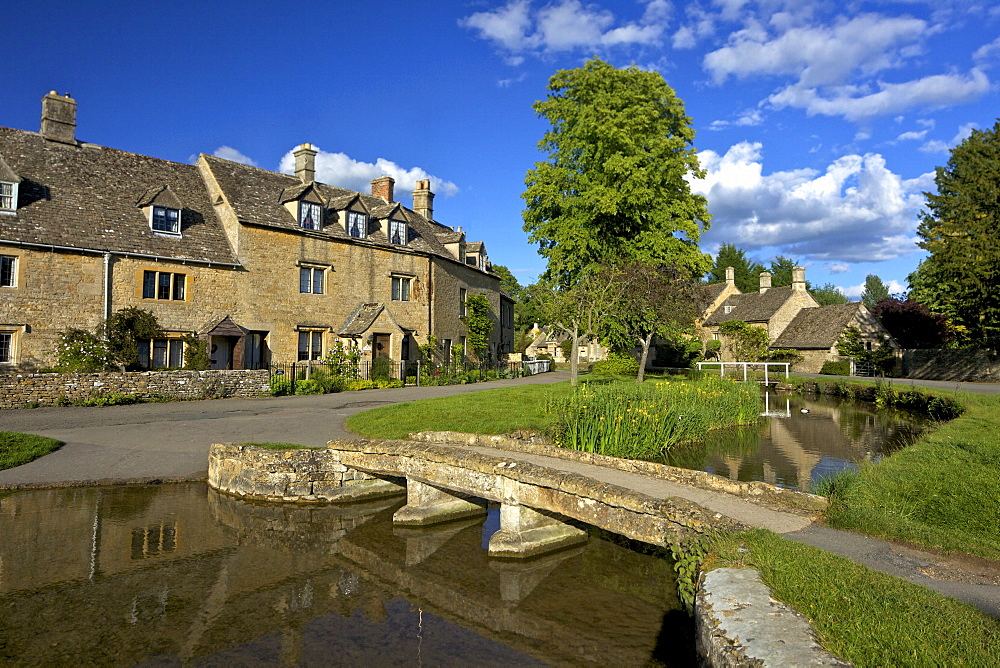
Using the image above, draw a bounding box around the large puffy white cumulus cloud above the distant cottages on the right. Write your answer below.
[691,142,933,263]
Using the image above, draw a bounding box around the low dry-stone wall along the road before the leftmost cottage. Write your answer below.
[0,369,270,409]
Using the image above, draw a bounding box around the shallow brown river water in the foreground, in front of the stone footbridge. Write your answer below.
[0,485,676,664]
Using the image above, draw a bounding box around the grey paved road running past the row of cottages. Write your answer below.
[0,371,569,489]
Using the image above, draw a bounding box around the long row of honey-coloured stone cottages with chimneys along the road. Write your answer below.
[0,92,513,371]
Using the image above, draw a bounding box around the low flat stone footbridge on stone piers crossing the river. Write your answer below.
[208,432,826,558]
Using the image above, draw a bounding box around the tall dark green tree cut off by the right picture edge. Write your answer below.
[911,122,1000,350]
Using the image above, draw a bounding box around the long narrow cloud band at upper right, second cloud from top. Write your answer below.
[768,68,990,121]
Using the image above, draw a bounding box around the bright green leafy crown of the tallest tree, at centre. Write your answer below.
[522,58,711,288]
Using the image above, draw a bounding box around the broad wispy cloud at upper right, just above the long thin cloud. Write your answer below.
[704,14,928,87]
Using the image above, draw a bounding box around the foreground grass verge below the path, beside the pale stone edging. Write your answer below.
[709,530,1000,666]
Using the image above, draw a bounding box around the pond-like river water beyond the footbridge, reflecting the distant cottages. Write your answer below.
[665,392,927,492]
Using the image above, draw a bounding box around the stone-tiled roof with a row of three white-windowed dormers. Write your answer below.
[201,154,472,260]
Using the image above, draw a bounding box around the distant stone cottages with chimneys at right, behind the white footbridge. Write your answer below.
[696,267,898,373]
